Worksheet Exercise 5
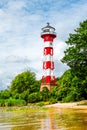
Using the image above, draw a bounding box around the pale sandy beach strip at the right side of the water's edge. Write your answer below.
[44,100,87,109]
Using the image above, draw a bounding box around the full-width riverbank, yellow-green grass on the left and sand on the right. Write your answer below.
[0,100,87,112]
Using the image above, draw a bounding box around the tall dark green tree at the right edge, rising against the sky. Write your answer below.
[62,20,87,79]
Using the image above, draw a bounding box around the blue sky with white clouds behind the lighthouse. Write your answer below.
[0,0,87,90]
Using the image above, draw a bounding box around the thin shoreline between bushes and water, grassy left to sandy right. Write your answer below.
[0,100,87,111]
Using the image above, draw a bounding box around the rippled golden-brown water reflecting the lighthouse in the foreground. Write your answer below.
[0,108,87,130]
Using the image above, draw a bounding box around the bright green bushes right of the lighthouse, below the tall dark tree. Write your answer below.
[55,69,87,102]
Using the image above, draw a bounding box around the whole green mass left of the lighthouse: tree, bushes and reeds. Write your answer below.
[0,71,42,106]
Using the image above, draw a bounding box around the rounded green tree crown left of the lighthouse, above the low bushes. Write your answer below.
[10,71,36,95]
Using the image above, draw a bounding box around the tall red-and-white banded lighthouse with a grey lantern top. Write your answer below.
[40,23,56,91]
